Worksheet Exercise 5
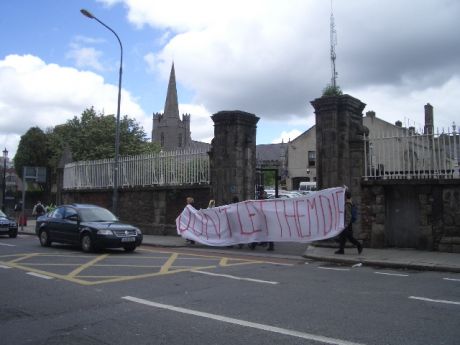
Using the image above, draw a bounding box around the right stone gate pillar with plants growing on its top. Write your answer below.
[311,95,366,198]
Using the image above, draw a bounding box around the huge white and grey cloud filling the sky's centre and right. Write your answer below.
[102,0,460,136]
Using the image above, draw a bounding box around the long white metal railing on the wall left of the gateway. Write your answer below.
[63,149,209,189]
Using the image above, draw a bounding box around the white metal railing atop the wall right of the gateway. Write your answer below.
[364,128,460,180]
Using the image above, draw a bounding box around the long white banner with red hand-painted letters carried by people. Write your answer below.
[176,187,345,246]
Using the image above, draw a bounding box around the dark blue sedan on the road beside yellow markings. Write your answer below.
[35,204,143,252]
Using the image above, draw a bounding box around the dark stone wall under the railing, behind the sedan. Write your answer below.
[62,185,210,235]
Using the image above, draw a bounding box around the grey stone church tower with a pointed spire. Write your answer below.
[152,63,192,151]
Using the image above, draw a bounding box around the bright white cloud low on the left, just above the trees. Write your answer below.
[0,55,147,157]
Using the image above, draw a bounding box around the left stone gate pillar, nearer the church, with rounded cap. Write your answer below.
[209,110,259,206]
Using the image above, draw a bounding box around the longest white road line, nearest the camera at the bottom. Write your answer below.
[122,296,363,345]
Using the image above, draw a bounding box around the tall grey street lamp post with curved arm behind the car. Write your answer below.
[80,9,123,214]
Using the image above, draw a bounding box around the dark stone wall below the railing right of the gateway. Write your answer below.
[362,180,460,253]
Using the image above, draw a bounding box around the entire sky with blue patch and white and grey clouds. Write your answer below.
[0,0,460,157]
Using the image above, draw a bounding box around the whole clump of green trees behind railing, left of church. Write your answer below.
[14,107,160,201]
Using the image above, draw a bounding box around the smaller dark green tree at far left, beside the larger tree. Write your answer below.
[14,127,48,177]
